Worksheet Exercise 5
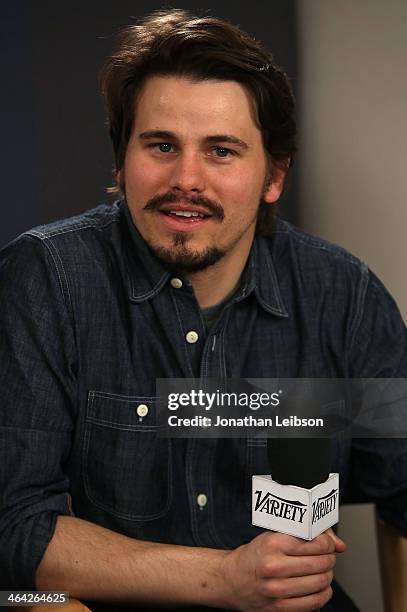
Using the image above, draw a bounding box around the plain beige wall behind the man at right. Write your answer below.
[298,0,407,612]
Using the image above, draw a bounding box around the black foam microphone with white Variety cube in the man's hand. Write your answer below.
[252,438,339,540]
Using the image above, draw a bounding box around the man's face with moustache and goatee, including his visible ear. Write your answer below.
[121,76,284,272]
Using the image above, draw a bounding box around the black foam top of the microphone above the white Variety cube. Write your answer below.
[267,438,332,489]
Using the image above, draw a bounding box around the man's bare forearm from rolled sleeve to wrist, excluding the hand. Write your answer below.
[37,516,227,605]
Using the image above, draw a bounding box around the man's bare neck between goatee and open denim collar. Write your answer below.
[188,237,255,308]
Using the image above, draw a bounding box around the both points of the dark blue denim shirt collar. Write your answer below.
[119,201,288,317]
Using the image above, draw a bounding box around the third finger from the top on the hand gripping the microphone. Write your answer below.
[259,570,333,599]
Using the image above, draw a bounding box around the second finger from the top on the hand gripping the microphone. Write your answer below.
[256,553,336,579]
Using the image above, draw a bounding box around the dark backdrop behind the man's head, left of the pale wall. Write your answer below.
[0,0,298,246]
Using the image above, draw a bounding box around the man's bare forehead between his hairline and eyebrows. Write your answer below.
[134,76,261,140]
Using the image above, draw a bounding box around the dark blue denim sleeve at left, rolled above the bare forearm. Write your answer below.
[0,235,77,590]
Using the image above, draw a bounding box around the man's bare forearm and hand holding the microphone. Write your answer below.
[37,517,345,611]
